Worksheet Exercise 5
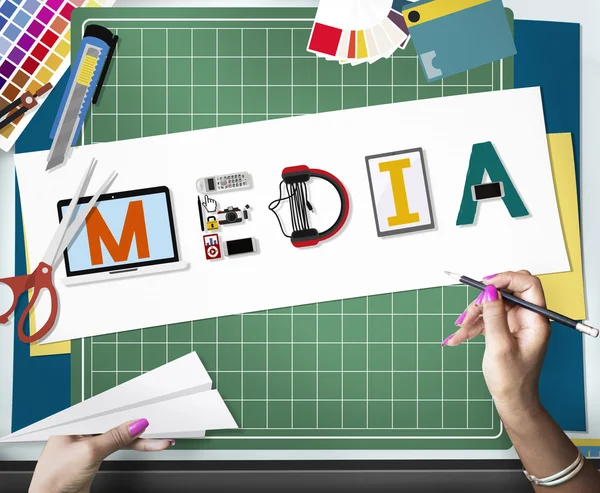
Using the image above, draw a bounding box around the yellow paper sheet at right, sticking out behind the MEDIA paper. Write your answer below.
[539,133,586,320]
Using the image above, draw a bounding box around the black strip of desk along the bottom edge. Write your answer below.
[0,460,600,493]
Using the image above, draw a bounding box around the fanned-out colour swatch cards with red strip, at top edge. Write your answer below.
[308,0,410,65]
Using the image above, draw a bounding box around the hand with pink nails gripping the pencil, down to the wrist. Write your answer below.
[448,271,550,418]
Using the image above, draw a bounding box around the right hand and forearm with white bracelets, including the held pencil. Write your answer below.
[450,271,600,492]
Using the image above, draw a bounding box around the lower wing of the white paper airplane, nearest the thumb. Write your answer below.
[0,390,237,443]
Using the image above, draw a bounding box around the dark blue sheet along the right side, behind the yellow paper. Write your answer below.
[515,21,586,431]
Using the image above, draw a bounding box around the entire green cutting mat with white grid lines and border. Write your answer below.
[71,9,513,450]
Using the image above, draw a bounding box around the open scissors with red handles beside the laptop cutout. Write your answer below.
[0,159,117,344]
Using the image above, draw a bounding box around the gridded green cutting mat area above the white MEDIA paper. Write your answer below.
[84,28,502,144]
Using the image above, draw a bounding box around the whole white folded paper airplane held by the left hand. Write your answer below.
[0,352,238,443]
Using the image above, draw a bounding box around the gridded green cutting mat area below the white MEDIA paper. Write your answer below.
[85,286,495,432]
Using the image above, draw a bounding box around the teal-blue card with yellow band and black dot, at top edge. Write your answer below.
[403,0,517,82]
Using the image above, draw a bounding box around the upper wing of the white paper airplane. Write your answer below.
[0,352,212,442]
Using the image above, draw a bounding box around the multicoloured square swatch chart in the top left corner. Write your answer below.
[0,0,115,151]
